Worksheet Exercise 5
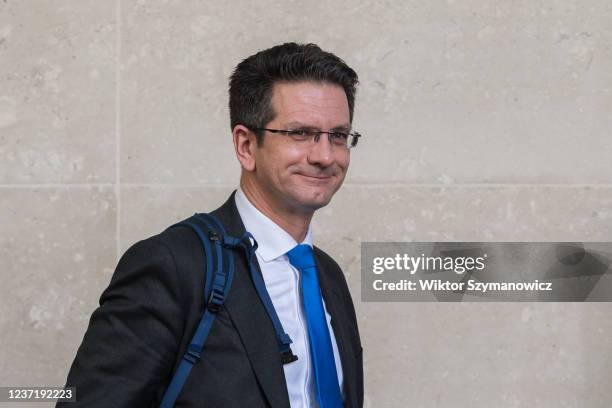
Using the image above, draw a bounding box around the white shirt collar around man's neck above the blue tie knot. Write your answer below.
[235,187,312,262]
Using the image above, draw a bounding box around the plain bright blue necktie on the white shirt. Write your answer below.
[287,244,342,408]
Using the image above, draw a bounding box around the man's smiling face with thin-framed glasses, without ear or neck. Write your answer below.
[254,82,350,213]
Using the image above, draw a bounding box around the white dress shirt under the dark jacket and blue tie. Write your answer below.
[235,188,344,408]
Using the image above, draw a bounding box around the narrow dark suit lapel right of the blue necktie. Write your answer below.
[315,250,357,407]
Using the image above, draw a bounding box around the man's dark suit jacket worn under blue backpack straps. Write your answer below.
[58,194,363,408]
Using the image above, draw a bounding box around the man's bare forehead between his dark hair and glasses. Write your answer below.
[272,82,350,127]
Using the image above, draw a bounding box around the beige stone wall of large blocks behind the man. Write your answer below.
[0,0,612,408]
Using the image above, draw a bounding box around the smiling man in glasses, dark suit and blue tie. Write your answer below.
[58,43,363,407]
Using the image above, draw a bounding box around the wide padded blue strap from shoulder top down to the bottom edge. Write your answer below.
[160,214,234,408]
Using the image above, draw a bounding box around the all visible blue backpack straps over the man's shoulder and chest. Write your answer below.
[160,213,298,408]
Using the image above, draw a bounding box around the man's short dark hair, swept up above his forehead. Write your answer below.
[229,42,359,144]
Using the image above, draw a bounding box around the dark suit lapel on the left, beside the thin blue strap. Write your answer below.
[213,191,289,407]
